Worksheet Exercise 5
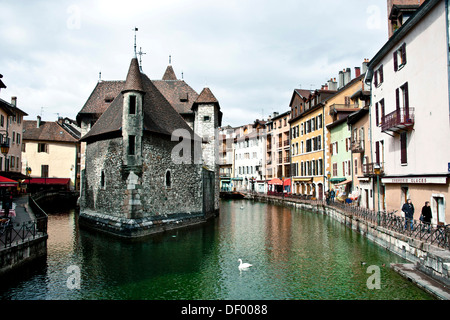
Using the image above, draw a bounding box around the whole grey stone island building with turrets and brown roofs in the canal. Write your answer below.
[77,58,222,237]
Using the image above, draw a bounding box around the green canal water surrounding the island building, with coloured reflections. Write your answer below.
[0,200,433,300]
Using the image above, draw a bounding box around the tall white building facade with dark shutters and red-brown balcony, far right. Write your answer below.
[366,0,450,225]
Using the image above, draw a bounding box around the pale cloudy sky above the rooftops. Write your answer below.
[0,0,387,126]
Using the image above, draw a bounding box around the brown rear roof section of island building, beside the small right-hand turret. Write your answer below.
[153,80,198,114]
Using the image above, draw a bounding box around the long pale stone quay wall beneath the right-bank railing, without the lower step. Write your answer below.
[247,195,450,286]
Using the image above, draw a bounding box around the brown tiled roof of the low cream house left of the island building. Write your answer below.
[23,120,78,143]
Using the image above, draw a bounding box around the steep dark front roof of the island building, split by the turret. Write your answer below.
[82,59,193,141]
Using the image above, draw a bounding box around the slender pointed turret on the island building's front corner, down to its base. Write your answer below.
[122,58,145,219]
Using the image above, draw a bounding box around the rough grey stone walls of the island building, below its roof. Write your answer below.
[80,130,218,237]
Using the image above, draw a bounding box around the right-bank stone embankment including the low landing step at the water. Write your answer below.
[246,194,450,300]
